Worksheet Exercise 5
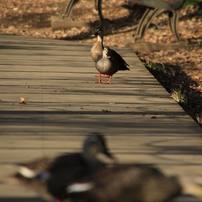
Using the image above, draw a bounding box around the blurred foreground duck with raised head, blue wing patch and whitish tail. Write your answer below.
[3,134,113,200]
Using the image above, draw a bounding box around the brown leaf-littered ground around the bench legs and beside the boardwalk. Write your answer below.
[0,0,202,125]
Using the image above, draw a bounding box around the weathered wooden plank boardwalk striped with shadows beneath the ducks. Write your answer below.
[0,35,202,202]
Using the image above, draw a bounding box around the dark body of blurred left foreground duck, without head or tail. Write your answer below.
[47,153,102,200]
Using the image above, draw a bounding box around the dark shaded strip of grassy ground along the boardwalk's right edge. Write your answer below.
[143,61,202,127]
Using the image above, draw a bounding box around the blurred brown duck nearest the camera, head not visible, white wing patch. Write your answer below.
[66,165,202,202]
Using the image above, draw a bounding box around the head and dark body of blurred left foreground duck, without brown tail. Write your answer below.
[47,135,113,200]
